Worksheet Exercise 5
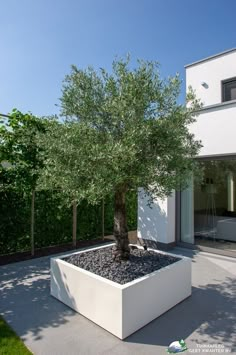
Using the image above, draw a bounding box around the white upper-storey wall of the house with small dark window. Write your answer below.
[186,50,236,156]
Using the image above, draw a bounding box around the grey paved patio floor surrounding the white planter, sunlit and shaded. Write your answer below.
[0,248,236,355]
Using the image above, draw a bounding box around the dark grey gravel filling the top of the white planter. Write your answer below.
[63,247,180,285]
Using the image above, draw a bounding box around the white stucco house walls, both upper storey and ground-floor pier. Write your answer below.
[138,49,236,248]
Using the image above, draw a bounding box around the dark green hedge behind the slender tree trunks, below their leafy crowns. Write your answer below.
[0,191,137,254]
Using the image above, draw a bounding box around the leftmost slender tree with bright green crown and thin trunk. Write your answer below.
[0,109,47,255]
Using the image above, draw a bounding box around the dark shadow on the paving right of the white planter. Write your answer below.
[125,277,236,351]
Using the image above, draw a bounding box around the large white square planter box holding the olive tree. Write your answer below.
[51,245,191,339]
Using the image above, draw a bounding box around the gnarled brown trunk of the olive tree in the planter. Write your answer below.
[113,188,130,261]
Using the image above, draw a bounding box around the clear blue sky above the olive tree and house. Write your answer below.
[0,0,236,116]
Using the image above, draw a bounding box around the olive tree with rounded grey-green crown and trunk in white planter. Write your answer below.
[39,58,200,260]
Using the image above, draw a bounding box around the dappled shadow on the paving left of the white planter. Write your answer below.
[0,258,75,340]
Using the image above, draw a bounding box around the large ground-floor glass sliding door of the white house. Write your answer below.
[180,159,236,255]
